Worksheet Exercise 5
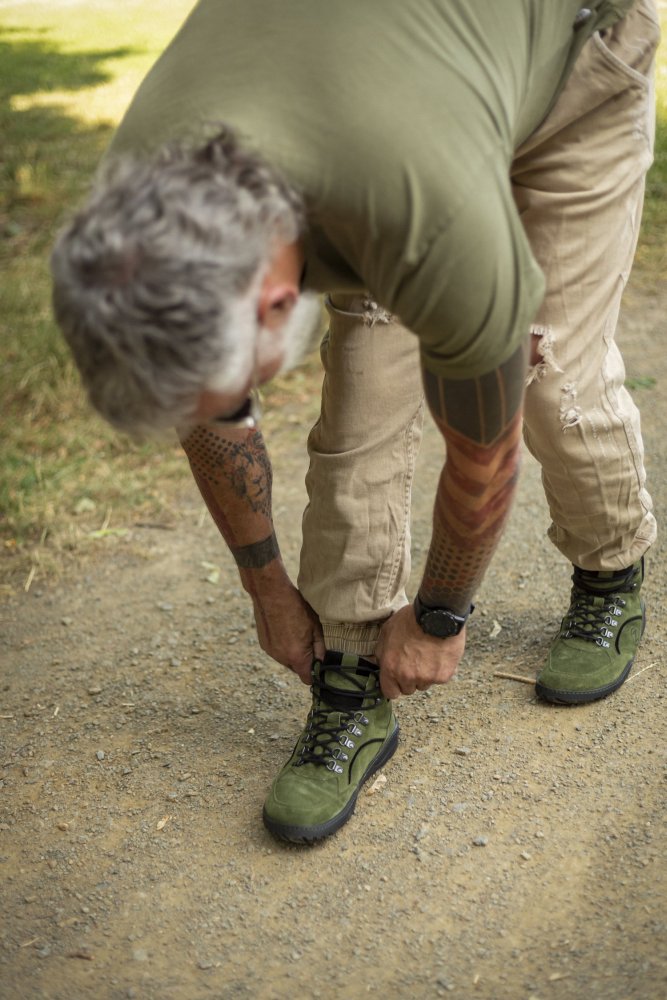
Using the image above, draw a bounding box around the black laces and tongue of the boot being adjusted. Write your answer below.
[295,664,382,774]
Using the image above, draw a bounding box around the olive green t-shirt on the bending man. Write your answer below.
[110,0,632,378]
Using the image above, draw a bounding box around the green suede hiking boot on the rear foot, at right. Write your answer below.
[536,558,646,705]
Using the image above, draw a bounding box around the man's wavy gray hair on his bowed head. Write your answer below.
[51,131,304,433]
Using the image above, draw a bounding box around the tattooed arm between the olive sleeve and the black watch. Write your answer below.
[419,348,525,613]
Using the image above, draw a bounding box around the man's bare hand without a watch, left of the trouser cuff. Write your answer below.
[251,577,324,684]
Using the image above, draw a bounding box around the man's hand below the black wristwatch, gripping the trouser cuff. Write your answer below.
[375,604,465,698]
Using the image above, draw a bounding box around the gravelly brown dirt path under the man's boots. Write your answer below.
[0,284,667,1000]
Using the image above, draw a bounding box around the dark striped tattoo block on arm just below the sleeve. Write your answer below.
[422,341,528,446]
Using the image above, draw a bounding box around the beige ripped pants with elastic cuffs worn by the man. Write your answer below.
[299,0,659,655]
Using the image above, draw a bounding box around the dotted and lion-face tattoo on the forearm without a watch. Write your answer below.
[183,426,272,517]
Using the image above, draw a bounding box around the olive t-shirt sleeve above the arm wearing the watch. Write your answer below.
[392,165,544,378]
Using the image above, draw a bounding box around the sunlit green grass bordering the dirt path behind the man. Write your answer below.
[0,0,667,584]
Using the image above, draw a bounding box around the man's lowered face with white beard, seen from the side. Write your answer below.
[194,293,322,423]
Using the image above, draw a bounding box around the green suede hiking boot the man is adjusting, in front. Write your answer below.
[263,653,398,843]
